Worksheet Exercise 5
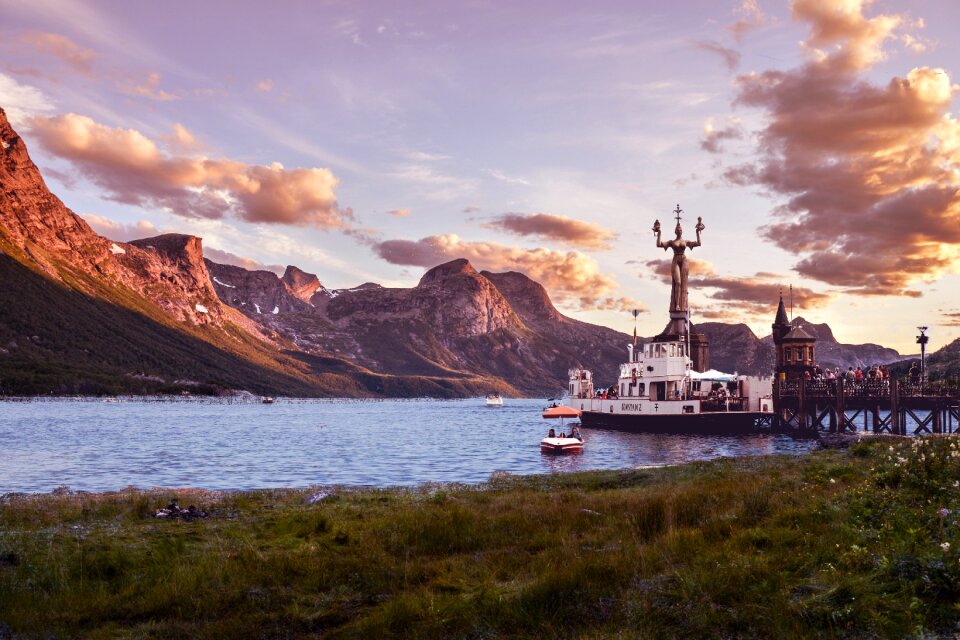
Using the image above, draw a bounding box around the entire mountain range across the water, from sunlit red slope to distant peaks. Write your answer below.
[0,105,928,397]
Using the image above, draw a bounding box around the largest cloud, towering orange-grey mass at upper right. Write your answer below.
[724,0,960,296]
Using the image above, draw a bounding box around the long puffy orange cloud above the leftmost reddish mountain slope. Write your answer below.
[31,113,353,229]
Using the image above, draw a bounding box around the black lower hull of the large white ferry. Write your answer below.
[580,411,767,434]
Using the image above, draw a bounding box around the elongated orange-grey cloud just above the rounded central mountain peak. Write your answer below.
[373,234,617,309]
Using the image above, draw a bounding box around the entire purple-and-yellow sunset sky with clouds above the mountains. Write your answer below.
[0,0,960,354]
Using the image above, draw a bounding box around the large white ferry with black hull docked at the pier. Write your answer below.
[568,339,773,434]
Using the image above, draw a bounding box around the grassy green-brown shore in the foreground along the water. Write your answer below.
[0,436,960,638]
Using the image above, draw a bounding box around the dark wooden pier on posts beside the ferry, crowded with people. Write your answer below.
[771,380,960,435]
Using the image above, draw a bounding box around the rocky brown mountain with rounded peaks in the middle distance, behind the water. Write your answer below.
[207,259,628,394]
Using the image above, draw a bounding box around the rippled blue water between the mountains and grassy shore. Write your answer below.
[0,399,815,493]
